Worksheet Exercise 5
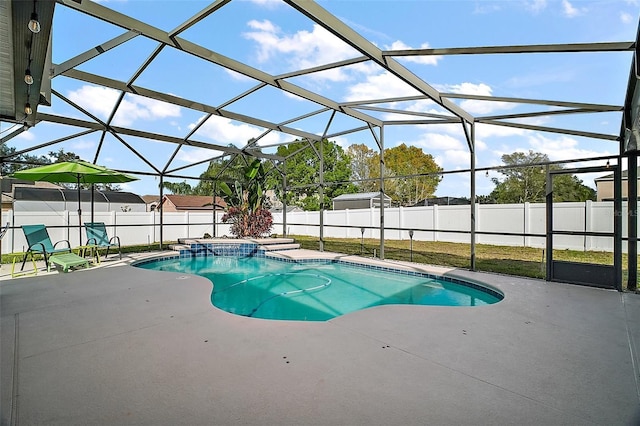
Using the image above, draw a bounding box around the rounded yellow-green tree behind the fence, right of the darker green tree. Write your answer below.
[362,143,442,205]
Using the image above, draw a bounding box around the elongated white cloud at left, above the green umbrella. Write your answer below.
[68,85,180,126]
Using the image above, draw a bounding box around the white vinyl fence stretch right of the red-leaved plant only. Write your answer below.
[274,201,628,251]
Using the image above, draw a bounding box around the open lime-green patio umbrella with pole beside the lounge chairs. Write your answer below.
[11,160,138,244]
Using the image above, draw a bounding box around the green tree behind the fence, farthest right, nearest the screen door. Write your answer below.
[489,150,596,204]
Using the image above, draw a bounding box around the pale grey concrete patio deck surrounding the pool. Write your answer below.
[0,250,640,425]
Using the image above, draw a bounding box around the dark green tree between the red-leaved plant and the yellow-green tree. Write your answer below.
[271,139,357,210]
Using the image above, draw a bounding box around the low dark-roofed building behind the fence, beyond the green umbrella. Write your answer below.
[13,185,146,212]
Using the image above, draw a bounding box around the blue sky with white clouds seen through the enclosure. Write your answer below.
[0,0,640,196]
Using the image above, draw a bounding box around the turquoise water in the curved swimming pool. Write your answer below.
[137,256,502,321]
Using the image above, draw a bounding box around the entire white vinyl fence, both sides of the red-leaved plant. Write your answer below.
[0,201,627,253]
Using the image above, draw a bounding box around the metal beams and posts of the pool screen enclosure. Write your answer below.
[0,0,640,290]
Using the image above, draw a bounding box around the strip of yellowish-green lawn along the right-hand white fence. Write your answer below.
[290,235,640,285]
